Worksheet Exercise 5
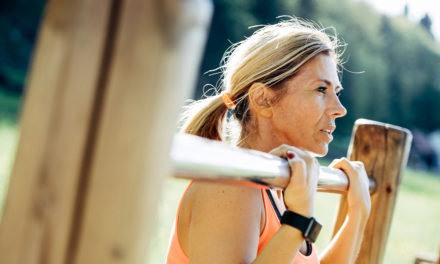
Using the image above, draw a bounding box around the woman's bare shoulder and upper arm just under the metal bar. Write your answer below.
[179,181,264,263]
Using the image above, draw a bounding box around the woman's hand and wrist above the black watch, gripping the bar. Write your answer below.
[270,145,319,217]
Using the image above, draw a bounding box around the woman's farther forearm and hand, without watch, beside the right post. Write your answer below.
[321,158,371,264]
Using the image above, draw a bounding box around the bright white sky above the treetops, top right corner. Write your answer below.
[358,0,440,41]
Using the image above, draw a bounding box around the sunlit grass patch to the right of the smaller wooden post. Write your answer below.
[385,169,440,263]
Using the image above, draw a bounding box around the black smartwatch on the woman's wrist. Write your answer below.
[280,210,322,243]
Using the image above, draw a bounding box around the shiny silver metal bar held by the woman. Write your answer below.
[170,134,375,193]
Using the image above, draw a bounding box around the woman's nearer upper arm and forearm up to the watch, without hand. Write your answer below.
[186,182,303,264]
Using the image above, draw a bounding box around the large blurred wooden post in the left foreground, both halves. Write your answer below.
[0,0,212,264]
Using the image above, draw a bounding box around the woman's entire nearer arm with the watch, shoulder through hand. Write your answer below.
[186,145,319,264]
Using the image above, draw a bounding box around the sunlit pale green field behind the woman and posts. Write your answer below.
[0,123,440,264]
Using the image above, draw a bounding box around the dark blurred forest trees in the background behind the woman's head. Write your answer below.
[0,0,440,134]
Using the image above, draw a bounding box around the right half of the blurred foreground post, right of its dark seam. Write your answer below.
[71,0,211,264]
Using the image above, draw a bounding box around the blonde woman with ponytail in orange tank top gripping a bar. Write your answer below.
[167,19,371,264]
